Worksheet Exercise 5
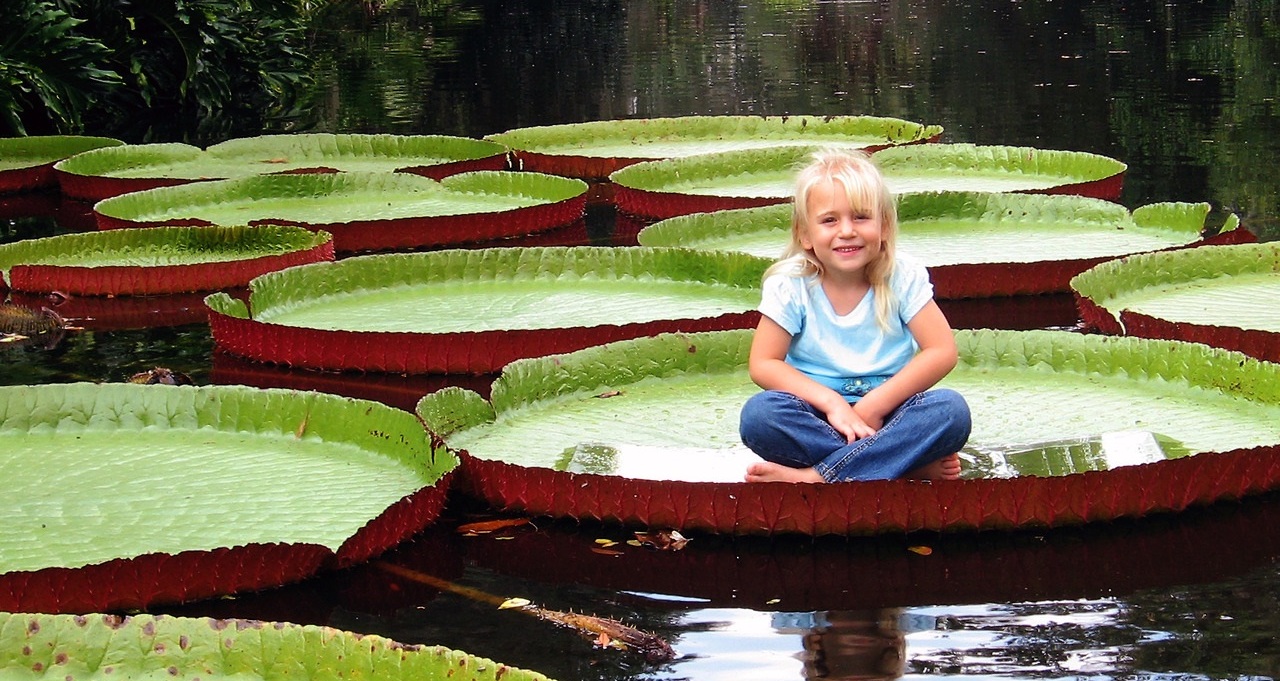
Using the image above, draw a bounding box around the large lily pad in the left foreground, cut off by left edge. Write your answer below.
[0,384,457,612]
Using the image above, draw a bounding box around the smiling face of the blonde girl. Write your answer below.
[800,180,882,282]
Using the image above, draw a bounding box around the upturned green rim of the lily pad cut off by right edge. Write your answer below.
[1070,242,1280,317]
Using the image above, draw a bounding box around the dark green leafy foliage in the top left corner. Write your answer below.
[0,0,308,138]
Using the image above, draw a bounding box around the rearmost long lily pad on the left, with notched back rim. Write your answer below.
[54,133,507,201]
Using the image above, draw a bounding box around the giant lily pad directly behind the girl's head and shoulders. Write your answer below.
[637,192,1253,298]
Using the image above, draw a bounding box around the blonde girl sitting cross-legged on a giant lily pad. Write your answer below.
[740,150,970,483]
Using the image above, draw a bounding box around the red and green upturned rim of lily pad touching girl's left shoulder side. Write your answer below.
[206,246,767,374]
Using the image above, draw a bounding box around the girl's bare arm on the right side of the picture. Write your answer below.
[854,300,959,430]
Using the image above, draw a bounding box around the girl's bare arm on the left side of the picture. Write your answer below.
[746,315,875,442]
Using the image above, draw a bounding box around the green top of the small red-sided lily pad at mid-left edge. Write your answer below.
[0,225,333,282]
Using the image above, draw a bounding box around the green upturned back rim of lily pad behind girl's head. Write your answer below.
[636,192,1210,250]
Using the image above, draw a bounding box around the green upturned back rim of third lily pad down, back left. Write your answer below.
[93,170,588,220]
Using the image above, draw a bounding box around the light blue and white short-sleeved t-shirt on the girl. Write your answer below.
[759,255,933,402]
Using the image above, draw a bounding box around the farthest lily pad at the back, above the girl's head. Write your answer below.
[485,115,942,180]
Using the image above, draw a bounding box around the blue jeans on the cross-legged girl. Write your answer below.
[739,388,972,483]
